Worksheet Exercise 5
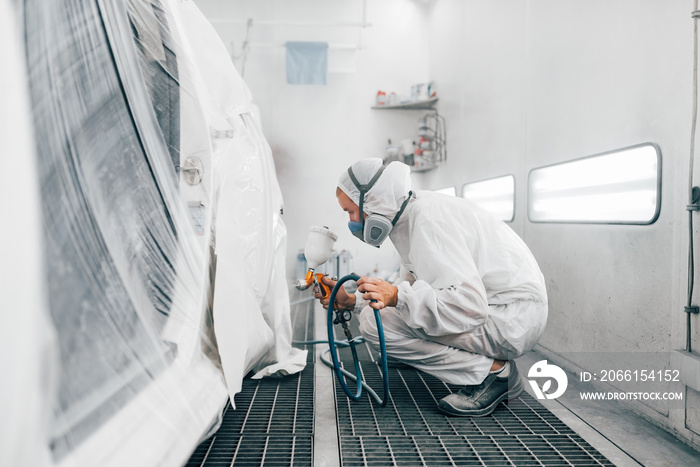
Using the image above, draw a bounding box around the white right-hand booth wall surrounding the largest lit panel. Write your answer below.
[429,0,700,445]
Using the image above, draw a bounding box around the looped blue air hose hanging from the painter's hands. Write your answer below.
[328,274,389,407]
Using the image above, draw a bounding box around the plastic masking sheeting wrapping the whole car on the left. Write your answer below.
[0,0,305,465]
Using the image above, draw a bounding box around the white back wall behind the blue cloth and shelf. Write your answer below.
[196,0,428,280]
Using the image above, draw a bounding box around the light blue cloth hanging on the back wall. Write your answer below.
[286,42,328,86]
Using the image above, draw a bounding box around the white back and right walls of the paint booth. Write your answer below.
[198,0,700,456]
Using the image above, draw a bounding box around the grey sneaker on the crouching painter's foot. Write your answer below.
[438,362,523,417]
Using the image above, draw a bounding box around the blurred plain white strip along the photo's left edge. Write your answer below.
[0,0,55,466]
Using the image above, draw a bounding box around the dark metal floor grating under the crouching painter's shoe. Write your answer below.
[335,322,614,466]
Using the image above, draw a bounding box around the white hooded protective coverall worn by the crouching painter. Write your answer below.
[338,159,547,385]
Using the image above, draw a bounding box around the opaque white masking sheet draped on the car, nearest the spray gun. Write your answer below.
[172,2,306,392]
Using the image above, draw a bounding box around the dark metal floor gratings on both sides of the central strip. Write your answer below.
[187,303,613,467]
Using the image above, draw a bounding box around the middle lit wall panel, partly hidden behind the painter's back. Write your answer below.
[462,175,515,222]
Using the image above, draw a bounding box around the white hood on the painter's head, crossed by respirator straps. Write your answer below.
[338,157,411,219]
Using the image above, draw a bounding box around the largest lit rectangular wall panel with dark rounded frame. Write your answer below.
[527,143,661,225]
